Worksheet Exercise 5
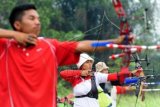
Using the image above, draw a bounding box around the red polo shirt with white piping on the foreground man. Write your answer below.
[0,38,79,107]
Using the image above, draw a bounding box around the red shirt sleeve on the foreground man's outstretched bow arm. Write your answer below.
[52,40,80,66]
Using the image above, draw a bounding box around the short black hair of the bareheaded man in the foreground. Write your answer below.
[9,4,37,30]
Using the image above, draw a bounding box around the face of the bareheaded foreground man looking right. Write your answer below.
[14,9,41,36]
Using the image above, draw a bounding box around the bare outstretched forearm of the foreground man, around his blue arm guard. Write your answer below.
[76,39,120,52]
